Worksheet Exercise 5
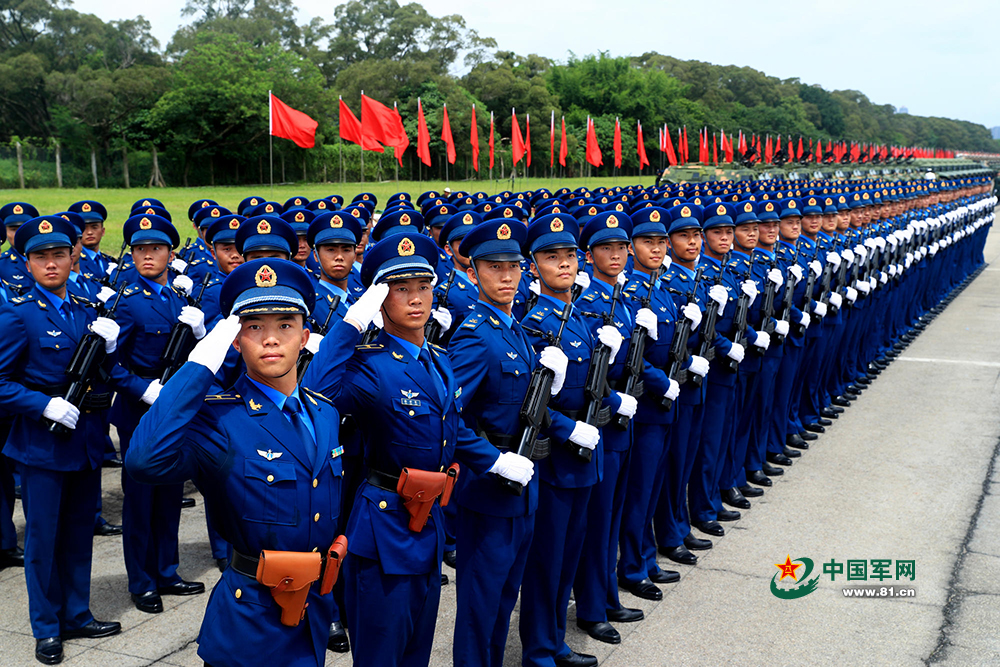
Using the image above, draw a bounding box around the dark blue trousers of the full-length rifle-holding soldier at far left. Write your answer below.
[21,466,101,639]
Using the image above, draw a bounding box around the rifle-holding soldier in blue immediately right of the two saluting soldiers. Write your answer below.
[448,218,576,667]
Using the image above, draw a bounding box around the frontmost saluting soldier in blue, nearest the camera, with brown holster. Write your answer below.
[125,258,350,666]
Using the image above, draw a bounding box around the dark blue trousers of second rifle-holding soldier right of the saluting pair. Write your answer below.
[519,481,593,667]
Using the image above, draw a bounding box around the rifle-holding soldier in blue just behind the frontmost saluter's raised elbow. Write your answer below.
[111,215,205,614]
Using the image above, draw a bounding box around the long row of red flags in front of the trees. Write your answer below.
[270,92,955,172]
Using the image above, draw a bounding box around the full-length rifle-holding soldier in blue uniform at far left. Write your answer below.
[0,216,121,664]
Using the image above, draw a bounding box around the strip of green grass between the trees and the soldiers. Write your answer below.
[0,175,654,254]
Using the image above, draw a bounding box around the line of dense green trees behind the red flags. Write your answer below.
[0,0,1000,185]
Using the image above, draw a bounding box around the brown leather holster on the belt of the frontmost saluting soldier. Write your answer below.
[257,535,347,628]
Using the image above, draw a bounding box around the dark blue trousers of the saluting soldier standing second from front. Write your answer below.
[344,554,441,667]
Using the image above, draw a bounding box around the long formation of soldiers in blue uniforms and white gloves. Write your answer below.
[0,174,997,666]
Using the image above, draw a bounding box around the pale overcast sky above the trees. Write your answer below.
[73,0,1000,127]
